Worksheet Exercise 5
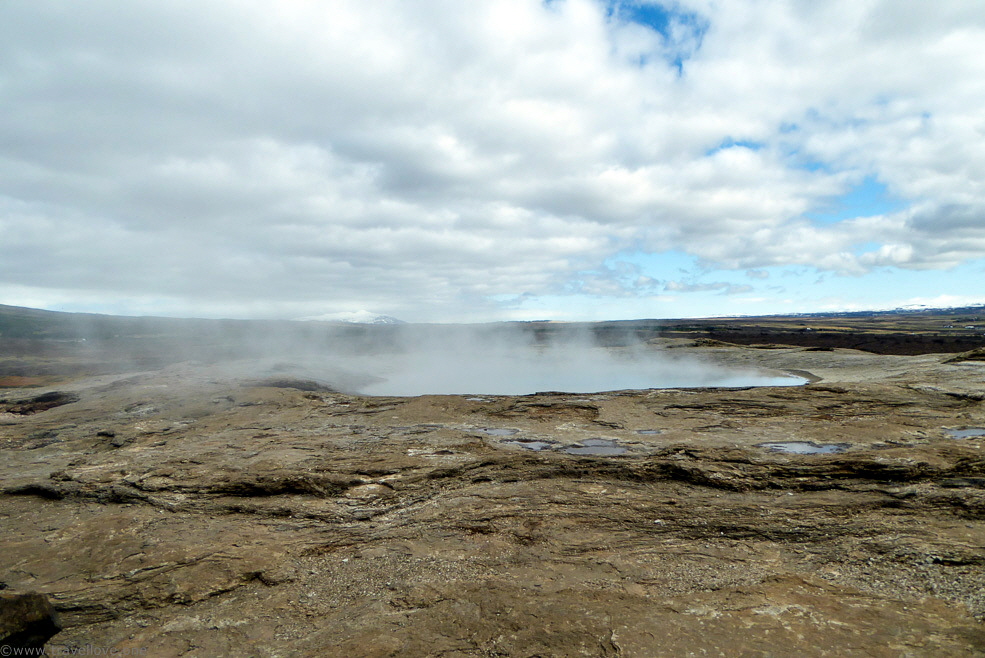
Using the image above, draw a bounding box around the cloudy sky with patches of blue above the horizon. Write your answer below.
[0,0,985,322]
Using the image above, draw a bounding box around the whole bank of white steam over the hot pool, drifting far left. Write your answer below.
[5,312,802,396]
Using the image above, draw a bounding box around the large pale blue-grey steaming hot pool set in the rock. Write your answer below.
[350,348,806,396]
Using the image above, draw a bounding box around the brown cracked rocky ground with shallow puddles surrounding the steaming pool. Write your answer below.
[0,339,985,656]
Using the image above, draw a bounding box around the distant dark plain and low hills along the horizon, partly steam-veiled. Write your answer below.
[0,305,985,356]
